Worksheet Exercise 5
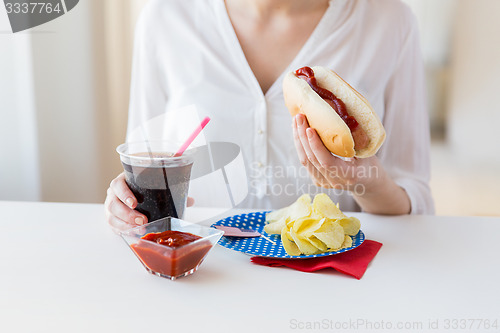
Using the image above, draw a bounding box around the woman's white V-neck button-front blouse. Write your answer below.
[128,0,434,214]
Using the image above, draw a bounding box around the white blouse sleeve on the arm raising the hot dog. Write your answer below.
[379,13,434,214]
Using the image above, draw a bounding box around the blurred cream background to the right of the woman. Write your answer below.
[405,0,500,215]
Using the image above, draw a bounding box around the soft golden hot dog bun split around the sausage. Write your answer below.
[283,66,385,158]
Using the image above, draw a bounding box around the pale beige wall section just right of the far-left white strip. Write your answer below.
[31,1,106,201]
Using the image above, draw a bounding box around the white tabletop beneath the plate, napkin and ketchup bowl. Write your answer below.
[0,202,500,332]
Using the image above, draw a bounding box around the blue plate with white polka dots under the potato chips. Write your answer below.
[212,212,365,259]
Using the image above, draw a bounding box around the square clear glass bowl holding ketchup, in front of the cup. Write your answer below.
[121,217,224,280]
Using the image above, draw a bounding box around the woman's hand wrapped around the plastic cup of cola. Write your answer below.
[104,172,148,233]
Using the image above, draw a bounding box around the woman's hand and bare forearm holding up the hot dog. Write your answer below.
[293,114,411,214]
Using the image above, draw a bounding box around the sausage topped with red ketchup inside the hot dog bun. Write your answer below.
[295,66,369,149]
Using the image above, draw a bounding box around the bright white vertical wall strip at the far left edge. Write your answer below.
[0,8,41,200]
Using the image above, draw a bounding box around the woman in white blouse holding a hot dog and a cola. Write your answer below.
[105,0,433,229]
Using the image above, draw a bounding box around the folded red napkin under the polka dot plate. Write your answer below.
[250,239,382,280]
